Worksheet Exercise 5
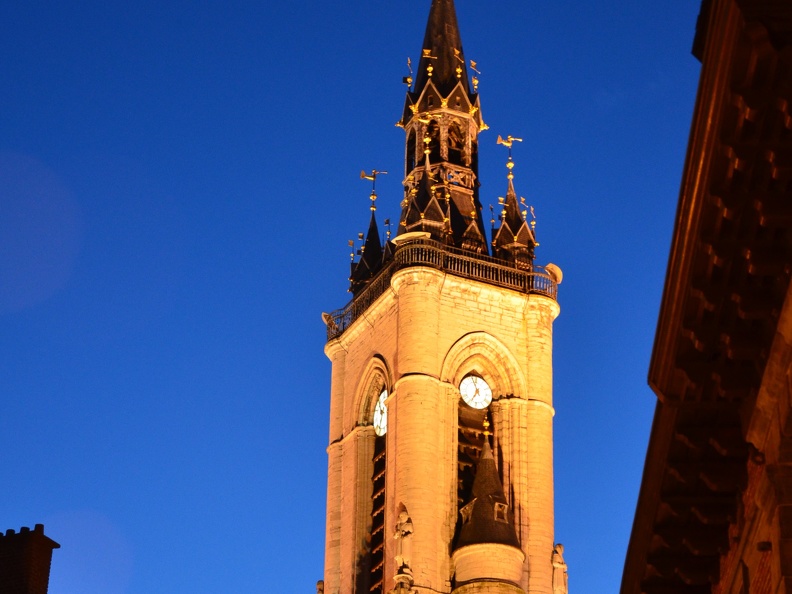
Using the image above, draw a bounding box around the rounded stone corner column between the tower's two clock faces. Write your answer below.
[385,268,457,593]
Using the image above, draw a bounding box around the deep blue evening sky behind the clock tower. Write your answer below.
[0,0,699,594]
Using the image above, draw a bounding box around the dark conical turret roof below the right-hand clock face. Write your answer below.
[456,440,520,549]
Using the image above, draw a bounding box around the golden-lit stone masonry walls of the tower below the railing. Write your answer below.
[325,267,559,594]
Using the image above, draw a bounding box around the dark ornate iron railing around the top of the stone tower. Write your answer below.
[326,239,558,340]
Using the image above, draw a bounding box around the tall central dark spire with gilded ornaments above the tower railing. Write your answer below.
[399,0,488,254]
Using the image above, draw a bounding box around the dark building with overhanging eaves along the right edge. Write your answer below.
[621,0,792,594]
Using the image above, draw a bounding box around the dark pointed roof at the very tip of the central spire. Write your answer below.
[414,0,470,97]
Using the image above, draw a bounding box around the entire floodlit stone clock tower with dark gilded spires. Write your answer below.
[320,0,566,594]
